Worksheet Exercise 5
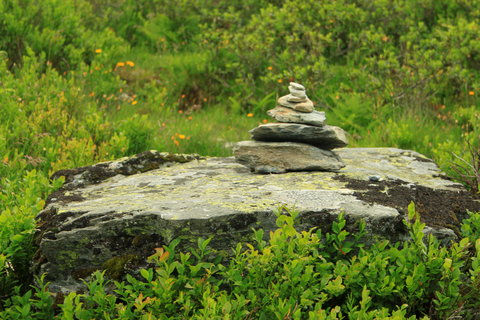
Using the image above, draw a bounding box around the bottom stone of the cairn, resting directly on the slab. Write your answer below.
[233,141,345,173]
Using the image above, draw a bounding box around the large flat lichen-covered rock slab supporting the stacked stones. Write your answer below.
[33,148,480,292]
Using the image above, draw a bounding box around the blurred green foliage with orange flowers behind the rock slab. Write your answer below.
[0,0,480,314]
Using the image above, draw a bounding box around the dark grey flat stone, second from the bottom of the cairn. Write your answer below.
[249,123,348,150]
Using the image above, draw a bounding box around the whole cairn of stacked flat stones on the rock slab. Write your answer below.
[233,82,348,174]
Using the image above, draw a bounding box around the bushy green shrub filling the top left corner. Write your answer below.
[0,0,125,72]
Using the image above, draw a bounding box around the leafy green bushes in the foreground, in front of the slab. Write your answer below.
[0,205,480,320]
